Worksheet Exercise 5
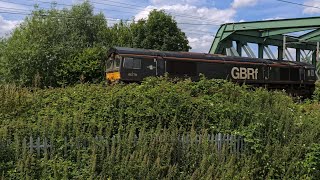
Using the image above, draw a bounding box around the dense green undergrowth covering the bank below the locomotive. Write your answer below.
[0,78,320,179]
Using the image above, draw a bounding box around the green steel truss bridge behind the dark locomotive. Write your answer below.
[209,17,320,77]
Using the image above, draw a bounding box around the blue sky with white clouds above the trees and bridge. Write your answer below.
[0,0,320,53]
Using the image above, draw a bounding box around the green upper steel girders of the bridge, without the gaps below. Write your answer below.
[209,17,320,67]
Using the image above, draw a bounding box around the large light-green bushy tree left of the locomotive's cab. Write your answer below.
[4,2,110,87]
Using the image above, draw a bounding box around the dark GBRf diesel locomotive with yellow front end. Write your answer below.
[106,47,317,97]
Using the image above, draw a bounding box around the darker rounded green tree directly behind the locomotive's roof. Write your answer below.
[131,10,191,51]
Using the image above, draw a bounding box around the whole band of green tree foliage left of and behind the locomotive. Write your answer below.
[0,2,190,87]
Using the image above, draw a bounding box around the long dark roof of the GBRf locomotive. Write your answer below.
[109,47,313,68]
